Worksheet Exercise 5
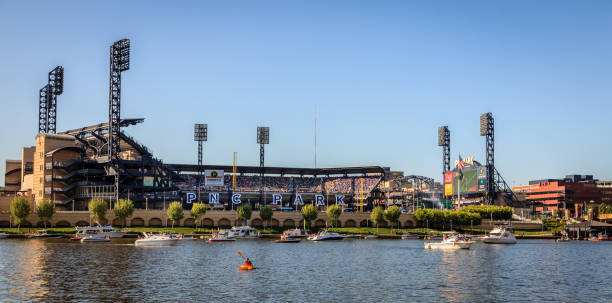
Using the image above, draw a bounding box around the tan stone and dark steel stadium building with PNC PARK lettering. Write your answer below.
[5,119,441,211]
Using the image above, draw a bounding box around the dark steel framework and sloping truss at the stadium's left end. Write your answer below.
[50,119,182,208]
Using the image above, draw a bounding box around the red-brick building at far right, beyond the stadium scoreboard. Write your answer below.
[512,175,612,217]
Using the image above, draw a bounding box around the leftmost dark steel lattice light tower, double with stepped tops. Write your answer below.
[38,66,64,134]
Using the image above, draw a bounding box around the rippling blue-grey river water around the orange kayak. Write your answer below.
[0,239,612,302]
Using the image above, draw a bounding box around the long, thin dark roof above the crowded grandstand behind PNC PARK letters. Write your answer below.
[168,164,385,176]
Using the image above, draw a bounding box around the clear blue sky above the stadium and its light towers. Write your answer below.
[0,0,612,185]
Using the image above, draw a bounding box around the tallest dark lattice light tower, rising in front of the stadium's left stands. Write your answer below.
[108,39,130,200]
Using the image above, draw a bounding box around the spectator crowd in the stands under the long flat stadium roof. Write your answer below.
[176,175,381,193]
